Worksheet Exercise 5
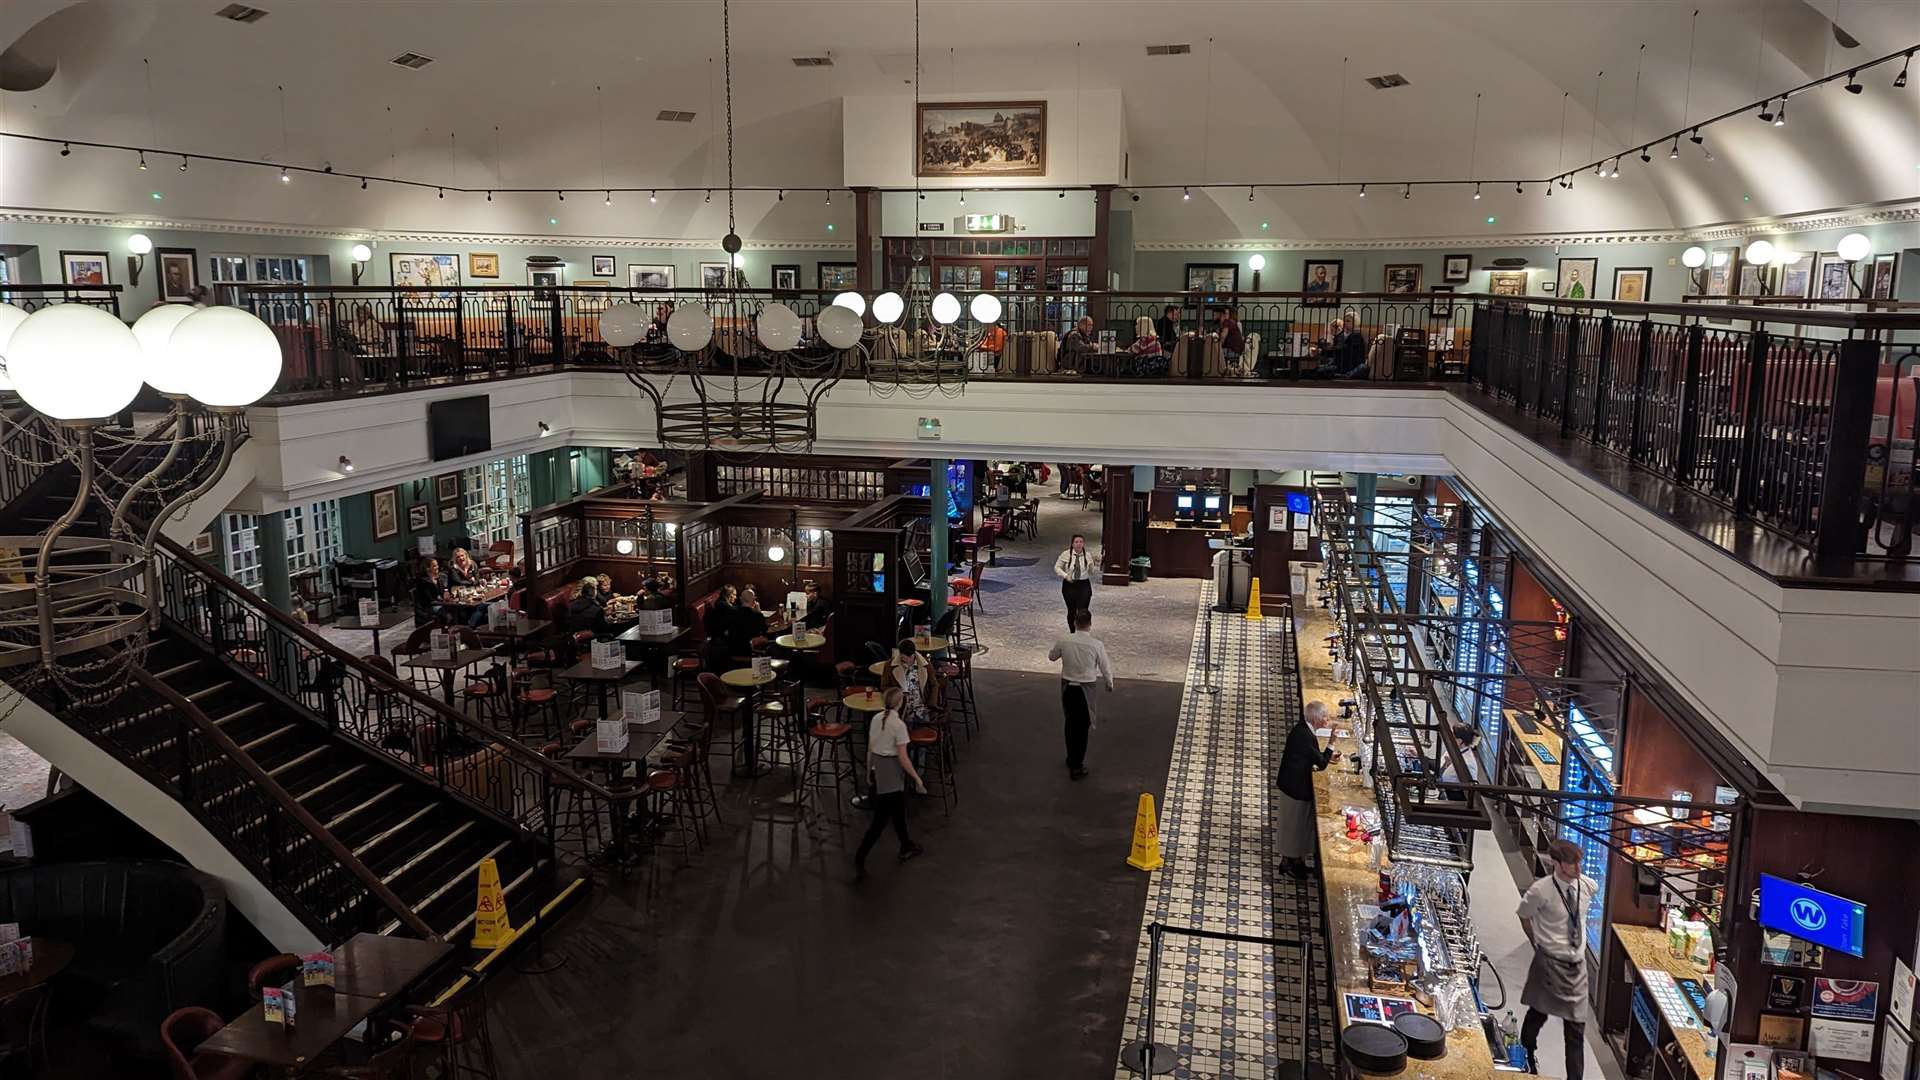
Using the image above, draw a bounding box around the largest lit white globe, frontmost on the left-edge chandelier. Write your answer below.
[6,304,142,421]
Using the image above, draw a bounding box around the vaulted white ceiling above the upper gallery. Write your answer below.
[0,0,1920,242]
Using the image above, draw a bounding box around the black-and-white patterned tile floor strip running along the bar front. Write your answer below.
[1116,582,1336,1080]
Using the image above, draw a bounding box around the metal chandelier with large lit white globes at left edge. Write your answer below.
[0,304,280,701]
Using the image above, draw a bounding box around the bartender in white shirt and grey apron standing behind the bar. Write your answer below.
[1519,840,1599,1080]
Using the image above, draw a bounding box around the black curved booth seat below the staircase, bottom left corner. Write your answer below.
[0,861,227,1059]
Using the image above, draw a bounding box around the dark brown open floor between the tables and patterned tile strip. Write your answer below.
[490,671,1181,1080]
